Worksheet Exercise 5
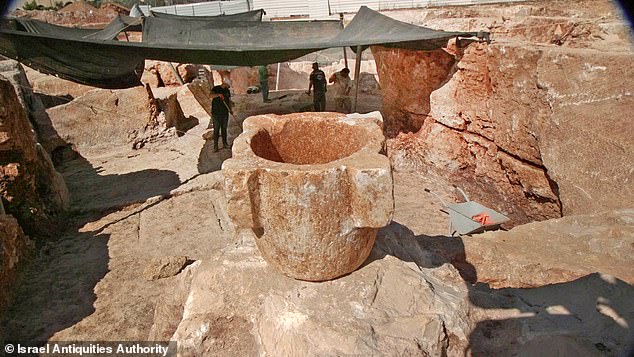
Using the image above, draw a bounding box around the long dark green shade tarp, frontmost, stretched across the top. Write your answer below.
[0,7,476,88]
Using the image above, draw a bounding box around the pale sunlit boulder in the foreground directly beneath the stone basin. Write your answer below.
[155,229,469,356]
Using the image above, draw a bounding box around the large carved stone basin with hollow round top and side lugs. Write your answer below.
[222,113,394,281]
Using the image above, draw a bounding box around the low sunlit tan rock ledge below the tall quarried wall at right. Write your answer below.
[425,208,634,289]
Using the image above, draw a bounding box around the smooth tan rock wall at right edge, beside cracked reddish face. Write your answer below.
[536,48,634,215]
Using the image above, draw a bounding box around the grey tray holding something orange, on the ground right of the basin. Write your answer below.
[425,187,509,236]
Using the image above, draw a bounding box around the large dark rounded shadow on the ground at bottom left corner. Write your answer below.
[0,225,110,343]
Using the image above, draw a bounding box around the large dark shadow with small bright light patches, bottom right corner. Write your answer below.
[465,273,634,356]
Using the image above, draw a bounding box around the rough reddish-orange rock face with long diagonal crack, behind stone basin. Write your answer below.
[373,44,560,224]
